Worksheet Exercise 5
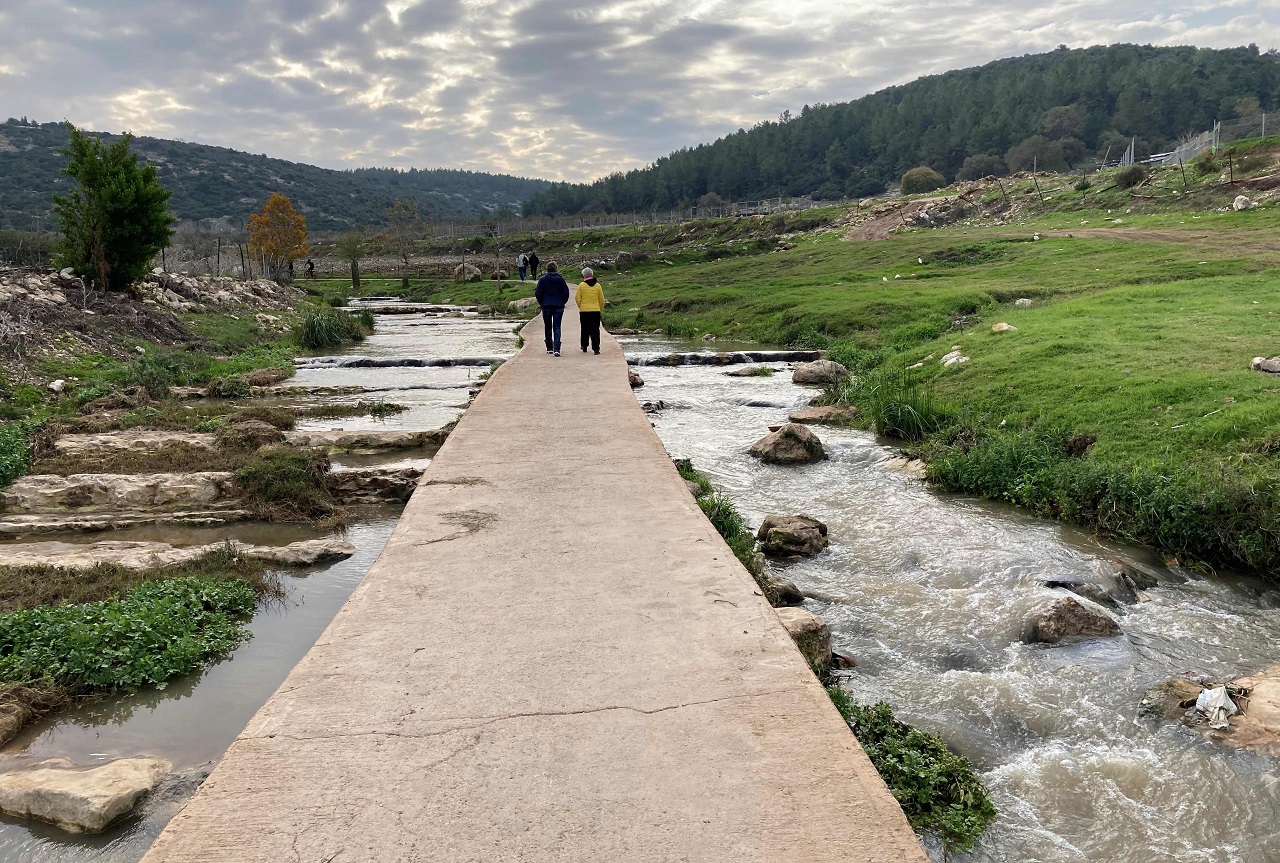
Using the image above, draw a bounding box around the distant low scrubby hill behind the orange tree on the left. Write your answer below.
[0,119,549,230]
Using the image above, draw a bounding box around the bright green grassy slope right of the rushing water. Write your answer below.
[422,158,1280,567]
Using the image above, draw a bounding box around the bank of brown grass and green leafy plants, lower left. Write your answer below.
[0,551,283,741]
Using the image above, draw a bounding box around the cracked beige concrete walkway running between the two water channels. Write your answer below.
[145,306,925,863]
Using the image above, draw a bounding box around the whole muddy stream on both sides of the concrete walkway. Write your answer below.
[0,314,1280,863]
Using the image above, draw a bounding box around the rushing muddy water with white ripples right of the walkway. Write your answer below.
[630,342,1280,863]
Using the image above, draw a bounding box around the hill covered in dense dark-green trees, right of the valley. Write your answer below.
[525,45,1280,215]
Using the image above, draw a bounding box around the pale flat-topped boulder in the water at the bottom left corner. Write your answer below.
[0,757,173,832]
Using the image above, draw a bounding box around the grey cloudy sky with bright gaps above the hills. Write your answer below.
[0,0,1280,179]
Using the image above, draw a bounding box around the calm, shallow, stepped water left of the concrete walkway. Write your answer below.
[0,309,516,863]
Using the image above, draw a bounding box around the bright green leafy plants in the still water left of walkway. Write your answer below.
[0,579,257,691]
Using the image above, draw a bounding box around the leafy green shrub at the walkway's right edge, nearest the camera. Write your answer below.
[827,686,996,851]
